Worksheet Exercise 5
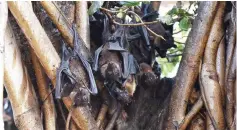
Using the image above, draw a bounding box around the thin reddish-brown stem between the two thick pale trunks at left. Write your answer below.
[30,48,56,130]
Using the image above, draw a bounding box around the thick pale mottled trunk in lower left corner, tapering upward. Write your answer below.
[4,24,43,130]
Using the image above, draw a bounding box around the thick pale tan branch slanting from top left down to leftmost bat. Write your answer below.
[8,1,60,80]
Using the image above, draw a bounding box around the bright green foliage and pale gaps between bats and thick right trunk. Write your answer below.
[157,2,197,77]
